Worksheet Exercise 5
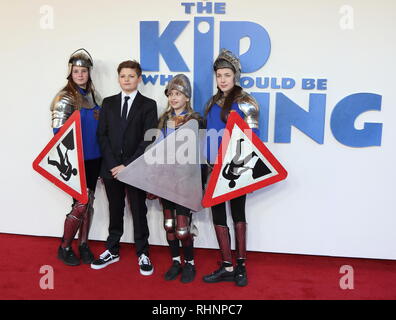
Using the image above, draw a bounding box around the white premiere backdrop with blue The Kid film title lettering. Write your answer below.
[0,0,396,259]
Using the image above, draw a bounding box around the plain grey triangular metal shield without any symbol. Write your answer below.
[118,119,203,211]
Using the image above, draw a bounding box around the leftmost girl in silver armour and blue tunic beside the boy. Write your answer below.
[48,49,101,266]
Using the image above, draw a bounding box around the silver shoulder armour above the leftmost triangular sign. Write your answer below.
[51,91,76,128]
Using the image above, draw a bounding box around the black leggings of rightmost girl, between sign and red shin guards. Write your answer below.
[212,195,246,226]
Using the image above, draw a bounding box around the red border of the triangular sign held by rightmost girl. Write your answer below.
[202,111,287,208]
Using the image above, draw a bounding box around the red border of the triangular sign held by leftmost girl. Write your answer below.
[33,110,88,203]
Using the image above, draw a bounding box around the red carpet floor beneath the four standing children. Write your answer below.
[0,234,396,300]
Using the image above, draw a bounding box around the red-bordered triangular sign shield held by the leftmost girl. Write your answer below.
[33,111,88,203]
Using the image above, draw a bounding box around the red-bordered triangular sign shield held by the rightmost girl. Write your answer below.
[202,111,287,207]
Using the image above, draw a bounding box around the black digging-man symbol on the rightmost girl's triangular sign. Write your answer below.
[222,139,271,188]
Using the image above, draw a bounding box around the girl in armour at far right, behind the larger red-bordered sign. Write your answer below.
[203,49,259,286]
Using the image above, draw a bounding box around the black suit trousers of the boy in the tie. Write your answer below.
[103,178,149,256]
